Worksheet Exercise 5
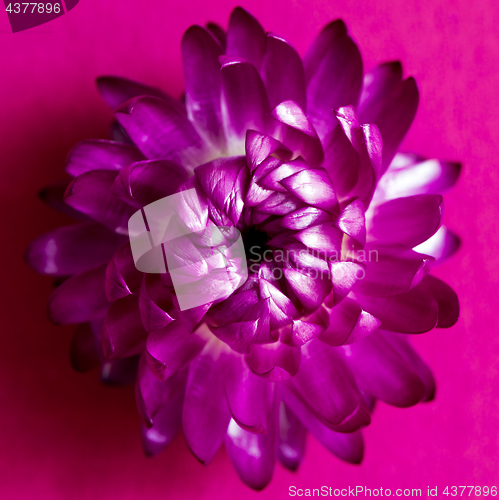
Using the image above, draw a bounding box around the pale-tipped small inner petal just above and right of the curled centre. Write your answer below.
[270,101,324,167]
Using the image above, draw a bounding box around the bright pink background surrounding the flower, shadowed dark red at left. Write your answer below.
[0,0,499,500]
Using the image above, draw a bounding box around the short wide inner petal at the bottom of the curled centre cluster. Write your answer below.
[244,341,301,382]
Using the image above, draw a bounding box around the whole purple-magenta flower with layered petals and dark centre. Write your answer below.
[27,8,460,489]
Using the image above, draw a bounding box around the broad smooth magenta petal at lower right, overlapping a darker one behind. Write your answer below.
[345,332,425,407]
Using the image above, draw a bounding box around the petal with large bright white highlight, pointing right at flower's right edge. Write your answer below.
[375,158,461,203]
